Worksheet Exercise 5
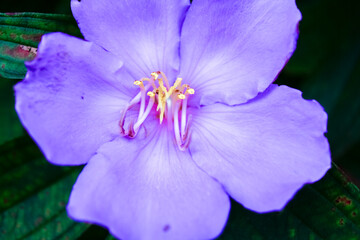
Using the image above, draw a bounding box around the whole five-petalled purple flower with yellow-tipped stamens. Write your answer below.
[15,0,330,239]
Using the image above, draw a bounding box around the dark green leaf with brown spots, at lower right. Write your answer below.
[219,165,360,240]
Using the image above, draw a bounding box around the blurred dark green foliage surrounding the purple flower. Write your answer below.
[0,0,360,240]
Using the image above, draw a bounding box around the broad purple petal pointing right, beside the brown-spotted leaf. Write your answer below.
[189,85,331,212]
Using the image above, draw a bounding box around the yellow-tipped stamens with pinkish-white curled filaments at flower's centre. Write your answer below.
[119,71,195,150]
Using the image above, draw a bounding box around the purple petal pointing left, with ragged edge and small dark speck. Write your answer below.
[15,33,136,165]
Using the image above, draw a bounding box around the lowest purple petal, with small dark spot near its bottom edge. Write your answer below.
[67,122,230,239]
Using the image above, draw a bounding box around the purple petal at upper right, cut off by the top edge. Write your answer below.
[180,0,301,105]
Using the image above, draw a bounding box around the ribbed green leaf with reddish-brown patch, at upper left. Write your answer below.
[0,13,81,79]
